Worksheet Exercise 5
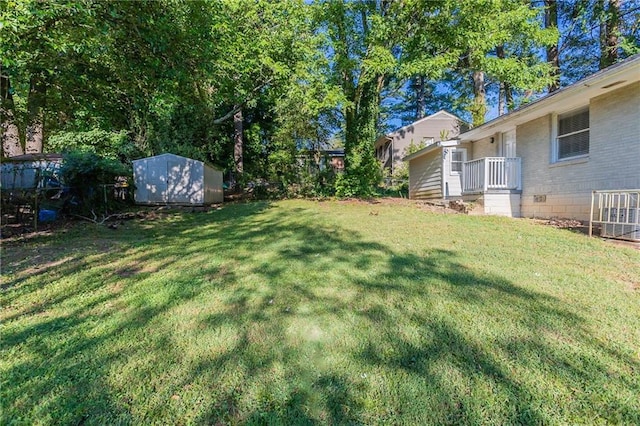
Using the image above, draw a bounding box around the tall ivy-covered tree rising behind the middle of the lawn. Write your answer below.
[322,1,396,196]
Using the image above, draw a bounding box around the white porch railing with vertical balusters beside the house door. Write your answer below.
[462,157,522,193]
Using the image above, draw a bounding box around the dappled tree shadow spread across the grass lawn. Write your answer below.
[2,203,640,424]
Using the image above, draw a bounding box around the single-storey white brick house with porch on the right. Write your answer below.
[405,55,640,228]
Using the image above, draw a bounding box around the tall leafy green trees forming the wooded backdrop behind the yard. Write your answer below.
[0,0,640,196]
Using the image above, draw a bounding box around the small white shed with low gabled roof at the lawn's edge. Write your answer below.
[133,154,223,205]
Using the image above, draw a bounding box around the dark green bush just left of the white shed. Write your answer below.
[61,151,131,214]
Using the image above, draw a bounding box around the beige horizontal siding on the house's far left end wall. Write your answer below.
[409,148,442,200]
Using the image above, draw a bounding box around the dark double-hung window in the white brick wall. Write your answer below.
[556,109,589,160]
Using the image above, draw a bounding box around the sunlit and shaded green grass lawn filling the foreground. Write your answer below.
[0,201,640,425]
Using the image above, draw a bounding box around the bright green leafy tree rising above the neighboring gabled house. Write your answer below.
[402,0,557,125]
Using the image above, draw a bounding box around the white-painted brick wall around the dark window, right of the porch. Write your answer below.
[516,83,640,220]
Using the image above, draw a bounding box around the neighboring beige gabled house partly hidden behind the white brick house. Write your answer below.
[374,110,466,173]
